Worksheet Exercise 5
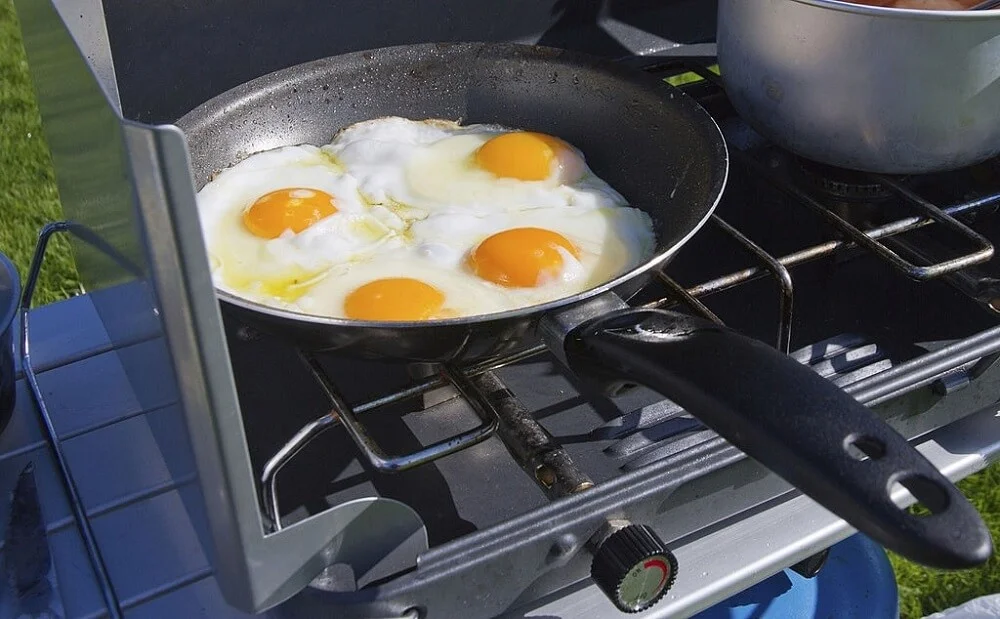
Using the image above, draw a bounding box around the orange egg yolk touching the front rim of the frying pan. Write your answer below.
[344,277,444,320]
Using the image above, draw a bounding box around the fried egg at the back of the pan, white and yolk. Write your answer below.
[323,117,626,213]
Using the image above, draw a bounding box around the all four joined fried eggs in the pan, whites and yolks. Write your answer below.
[198,117,656,321]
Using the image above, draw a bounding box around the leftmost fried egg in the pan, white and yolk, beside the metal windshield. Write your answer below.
[197,141,405,307]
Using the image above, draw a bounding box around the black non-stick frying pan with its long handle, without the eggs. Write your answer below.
[177,43,992,568]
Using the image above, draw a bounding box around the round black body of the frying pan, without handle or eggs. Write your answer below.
[177,44,728,361]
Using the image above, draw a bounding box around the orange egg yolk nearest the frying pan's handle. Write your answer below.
[468,228,579,288]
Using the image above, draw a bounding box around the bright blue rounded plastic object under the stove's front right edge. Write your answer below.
[696,534,899,619]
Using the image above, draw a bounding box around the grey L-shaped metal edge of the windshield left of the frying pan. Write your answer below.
[120,121,426,612]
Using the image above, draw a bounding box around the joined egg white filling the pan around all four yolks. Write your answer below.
[198,123,656,318]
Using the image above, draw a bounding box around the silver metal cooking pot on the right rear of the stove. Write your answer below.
[717,0,1000,174]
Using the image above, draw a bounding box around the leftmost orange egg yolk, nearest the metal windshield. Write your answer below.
[243,187,337,239]
